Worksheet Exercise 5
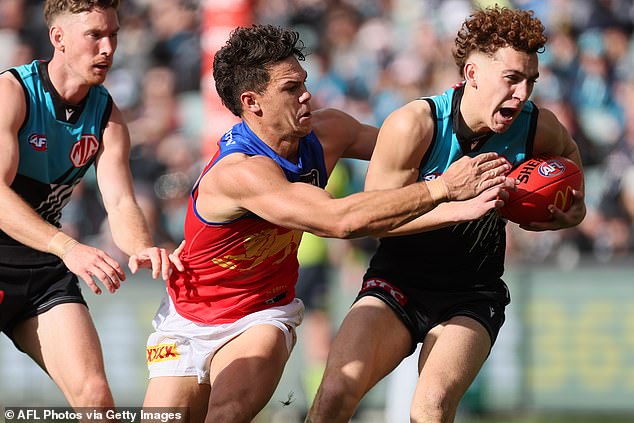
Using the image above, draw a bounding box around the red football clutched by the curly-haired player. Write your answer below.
[500,155,583,224]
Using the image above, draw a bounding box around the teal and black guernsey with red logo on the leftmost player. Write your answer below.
[0,61,112,265]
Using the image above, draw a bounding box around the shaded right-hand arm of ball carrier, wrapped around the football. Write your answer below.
[520,109,586,231]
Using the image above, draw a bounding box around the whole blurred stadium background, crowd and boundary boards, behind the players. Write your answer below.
[0,0,634,423]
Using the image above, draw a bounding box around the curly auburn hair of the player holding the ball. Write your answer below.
[453,5,547,76]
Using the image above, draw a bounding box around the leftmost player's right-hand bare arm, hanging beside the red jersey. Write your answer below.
[96,105,170,280]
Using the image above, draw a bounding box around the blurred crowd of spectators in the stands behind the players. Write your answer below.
[0,0,634,267]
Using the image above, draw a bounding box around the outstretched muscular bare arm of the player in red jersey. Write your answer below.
[197,136,503,238]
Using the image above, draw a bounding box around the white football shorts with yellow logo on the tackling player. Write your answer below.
[146,295,304,384]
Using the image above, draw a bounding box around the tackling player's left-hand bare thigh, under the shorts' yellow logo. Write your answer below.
[143,376,211,423]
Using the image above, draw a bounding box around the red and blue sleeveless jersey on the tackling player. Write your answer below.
[168,122,327,324]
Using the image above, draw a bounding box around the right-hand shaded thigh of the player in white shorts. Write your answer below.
[209,324,294,412]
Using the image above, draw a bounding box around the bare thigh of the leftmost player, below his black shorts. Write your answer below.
[13,303,105,383]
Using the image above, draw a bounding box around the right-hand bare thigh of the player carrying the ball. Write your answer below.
[415,316,491,401]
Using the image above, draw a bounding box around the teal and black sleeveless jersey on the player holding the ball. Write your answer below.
[366,84,538,291]
